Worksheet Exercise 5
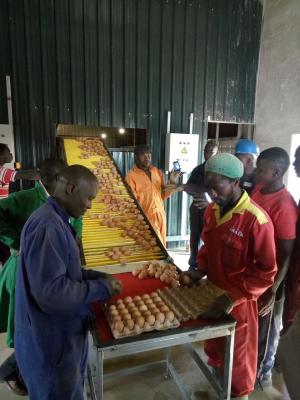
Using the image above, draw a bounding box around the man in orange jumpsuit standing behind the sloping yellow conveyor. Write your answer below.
[126,145,180,245]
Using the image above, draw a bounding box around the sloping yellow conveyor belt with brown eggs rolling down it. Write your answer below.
[63,137,166,272]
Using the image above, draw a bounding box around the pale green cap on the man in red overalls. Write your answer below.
[205,153,244,179]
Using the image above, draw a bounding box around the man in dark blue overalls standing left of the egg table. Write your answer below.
[15,165,121,400]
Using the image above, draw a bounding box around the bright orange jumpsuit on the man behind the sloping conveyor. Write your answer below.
[126,165,171,245]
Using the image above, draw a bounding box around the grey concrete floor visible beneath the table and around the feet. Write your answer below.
[0,336,289,400]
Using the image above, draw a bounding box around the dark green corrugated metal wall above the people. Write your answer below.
[0,0,262,166]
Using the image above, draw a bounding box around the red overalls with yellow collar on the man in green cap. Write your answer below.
[198,192,277,397]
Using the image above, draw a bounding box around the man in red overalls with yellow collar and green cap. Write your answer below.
[191,153,277,399]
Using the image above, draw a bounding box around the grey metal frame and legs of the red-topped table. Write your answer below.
[88,318,235,400]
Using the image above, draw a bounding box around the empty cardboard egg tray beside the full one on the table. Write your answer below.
[157,281,225,321]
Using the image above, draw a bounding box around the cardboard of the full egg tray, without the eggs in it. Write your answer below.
[102,292,180,339]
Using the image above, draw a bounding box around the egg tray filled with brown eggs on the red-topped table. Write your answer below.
[103,292,180,339]
